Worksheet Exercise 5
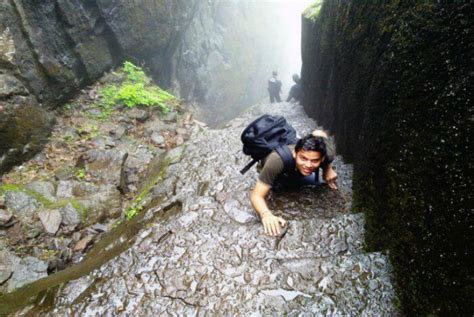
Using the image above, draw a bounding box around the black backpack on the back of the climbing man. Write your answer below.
[240,114,297,174]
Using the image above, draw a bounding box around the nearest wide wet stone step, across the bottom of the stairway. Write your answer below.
[49,249,396,316]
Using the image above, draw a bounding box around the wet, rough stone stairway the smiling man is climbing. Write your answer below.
[50,103,398,316]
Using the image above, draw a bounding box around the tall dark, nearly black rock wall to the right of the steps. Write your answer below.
[302,0,474,315]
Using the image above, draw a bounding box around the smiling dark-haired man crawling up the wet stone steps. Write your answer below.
[250,130,337,236]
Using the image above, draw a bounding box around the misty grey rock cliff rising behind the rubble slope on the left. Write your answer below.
[0,0,283,173]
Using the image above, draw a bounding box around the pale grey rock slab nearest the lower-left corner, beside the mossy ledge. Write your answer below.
[7,257,48,292]
